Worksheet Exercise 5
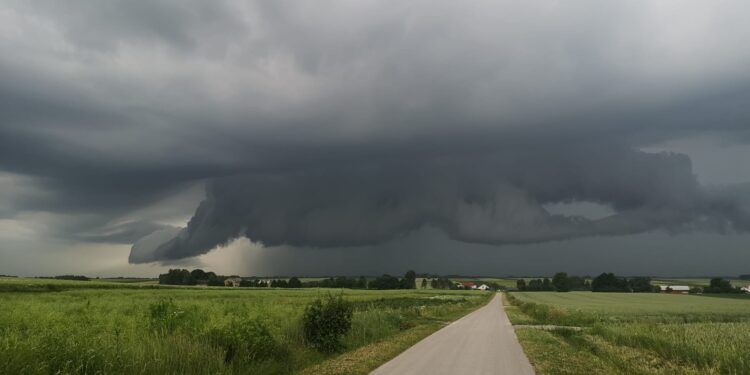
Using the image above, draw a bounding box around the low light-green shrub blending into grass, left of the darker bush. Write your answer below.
[207,319,284,363]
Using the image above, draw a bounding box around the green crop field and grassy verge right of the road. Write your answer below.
[506,292,750,374]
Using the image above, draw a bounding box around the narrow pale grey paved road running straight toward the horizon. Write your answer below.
[371,294,534,375]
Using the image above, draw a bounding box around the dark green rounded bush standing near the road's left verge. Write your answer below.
[302,295,353,353]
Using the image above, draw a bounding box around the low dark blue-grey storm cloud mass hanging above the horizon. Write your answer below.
[131,143,750,261]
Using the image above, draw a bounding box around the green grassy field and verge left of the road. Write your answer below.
[0,278,490,374]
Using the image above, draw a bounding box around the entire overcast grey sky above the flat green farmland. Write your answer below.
[0,0,750,276]
